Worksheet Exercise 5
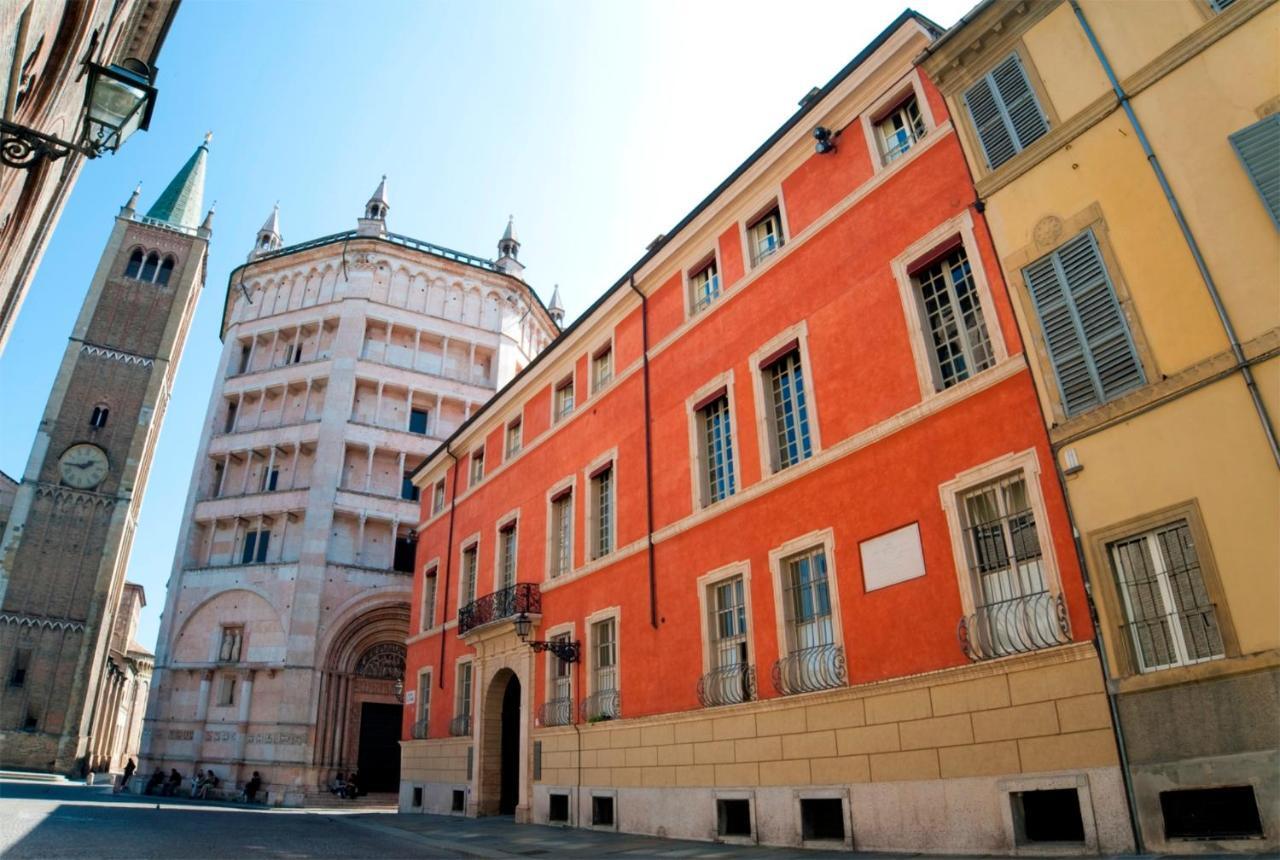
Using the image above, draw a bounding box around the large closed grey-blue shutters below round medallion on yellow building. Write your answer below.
[1023,230,1147,415]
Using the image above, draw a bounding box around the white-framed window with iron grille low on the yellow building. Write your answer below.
[1107,520,1226,672]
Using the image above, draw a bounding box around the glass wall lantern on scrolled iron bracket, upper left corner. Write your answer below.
[0,58,156,170]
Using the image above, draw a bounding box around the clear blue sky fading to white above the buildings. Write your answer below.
[0,0,973,646]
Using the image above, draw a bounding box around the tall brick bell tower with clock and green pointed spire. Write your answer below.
[0,136,212,776]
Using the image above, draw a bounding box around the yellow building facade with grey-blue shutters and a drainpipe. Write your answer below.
[920,0,1280,852]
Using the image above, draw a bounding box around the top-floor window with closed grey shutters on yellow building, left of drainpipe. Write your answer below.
[964,54,1048,170]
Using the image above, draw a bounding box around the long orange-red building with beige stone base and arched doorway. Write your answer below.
[401,12,1132,854]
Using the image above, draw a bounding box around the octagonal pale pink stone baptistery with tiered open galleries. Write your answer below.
[138,179,561,805]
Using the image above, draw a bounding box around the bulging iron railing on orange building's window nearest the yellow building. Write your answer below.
[956,591,1071,660]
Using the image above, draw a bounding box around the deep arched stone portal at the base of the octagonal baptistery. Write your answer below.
[315,603,408,792]
